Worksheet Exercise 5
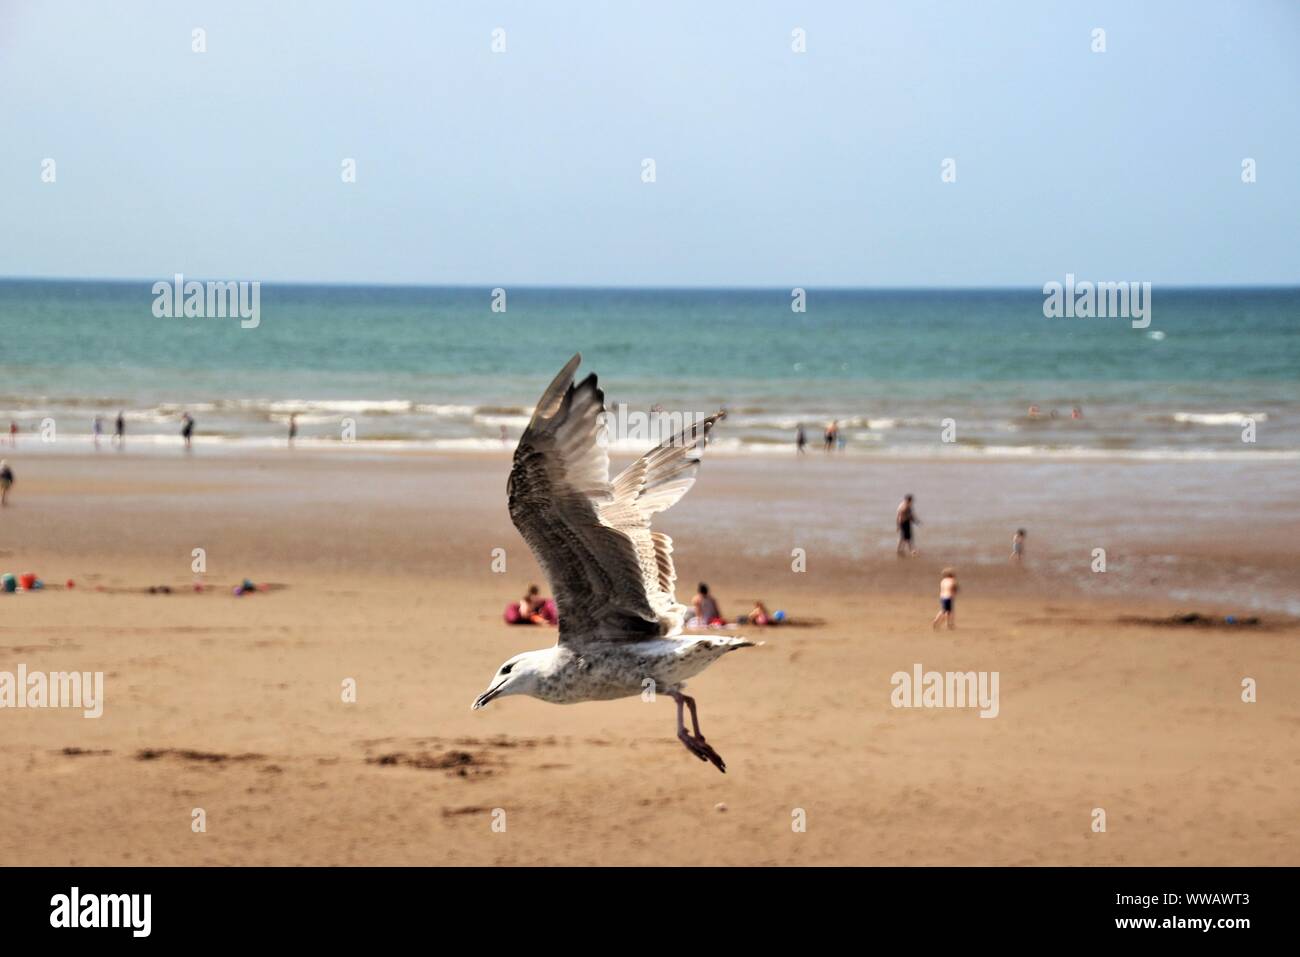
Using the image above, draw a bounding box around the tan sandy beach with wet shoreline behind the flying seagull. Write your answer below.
[0,447,1300,865]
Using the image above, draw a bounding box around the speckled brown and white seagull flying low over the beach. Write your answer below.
[472,354,762,774]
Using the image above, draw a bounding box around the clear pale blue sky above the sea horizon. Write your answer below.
[0,0,1300,286]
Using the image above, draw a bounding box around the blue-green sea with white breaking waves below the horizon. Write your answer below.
[0,277,1300,460]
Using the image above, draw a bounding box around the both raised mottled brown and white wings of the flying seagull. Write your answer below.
[507,355,718,644]
